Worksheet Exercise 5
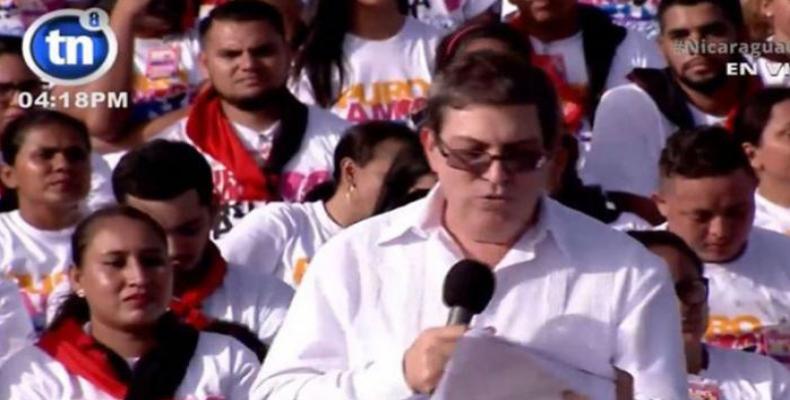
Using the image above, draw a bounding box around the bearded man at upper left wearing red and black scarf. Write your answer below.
[155,0,348,239]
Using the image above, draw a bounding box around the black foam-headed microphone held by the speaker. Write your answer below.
[442,260,494,326]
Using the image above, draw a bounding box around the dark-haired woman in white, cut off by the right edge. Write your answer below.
[734,88,790,235]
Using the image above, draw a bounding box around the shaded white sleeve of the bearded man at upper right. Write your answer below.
[582,85,665,197]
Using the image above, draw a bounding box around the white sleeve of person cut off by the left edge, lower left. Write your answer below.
[0,280,34,366]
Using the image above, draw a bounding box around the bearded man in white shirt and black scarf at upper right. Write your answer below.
[582,0,756,197]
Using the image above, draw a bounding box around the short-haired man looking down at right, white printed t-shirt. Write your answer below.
[655,127,790,365]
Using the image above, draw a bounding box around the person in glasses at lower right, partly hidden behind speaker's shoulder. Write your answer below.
[629,231,790,400]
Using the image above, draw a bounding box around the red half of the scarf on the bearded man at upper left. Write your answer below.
[186,89,278,201]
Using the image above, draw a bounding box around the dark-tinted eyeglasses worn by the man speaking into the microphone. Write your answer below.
[437,136,548,175]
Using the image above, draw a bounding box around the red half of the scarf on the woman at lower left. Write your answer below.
[37,319,128,399]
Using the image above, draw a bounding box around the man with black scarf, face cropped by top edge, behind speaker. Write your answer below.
[508,0,666,138]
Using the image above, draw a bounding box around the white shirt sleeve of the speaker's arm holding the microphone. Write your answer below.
[250,241,412,400]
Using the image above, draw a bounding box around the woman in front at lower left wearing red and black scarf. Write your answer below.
[0,206,260,400]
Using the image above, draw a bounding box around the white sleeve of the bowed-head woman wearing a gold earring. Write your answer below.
[217,203,294,280]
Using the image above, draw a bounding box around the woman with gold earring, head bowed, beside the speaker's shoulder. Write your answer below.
[218,121,422,287]
